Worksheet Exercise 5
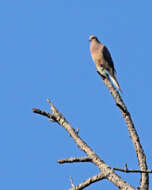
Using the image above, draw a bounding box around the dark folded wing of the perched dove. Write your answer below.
[102,46,116,73]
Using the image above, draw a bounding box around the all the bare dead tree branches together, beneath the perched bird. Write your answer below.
[33,72,151,190]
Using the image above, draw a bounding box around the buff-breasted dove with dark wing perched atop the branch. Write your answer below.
[89,35,122,92]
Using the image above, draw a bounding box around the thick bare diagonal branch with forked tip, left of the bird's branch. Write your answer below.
[34,102,135,190]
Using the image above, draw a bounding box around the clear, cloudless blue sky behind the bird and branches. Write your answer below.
[0,0,152,190]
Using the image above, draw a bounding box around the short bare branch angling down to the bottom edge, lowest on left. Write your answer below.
[69,173,105,190]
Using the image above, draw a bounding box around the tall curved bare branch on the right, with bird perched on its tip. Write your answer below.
[98,72,149,190]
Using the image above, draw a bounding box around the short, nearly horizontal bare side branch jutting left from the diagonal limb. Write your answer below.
[58,156,92,164]
